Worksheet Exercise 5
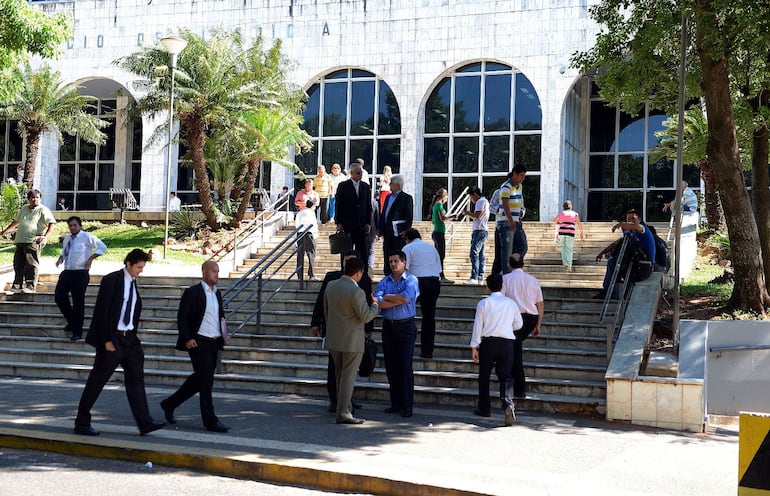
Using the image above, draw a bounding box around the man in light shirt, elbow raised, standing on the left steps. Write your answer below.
[54,215,107,341]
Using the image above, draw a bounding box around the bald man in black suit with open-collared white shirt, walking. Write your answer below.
[160,260,230,432]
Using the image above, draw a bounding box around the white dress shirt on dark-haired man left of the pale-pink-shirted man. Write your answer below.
[464,291,524,348]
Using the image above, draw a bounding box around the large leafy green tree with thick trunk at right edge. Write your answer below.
[573,0,770,312]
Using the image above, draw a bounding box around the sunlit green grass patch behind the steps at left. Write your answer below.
[0,222,207,265]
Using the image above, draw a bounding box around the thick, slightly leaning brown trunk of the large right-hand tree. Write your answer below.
[695,0,770,313]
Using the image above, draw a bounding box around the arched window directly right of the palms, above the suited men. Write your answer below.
[296,69,401,184]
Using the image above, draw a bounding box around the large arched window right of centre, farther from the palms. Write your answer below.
[422,62,542,220]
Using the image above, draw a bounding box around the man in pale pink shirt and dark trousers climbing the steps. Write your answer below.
[503,253,544,399]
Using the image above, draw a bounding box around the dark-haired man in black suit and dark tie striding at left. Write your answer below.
[75,249,166,436]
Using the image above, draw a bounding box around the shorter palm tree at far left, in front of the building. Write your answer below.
[0,63,108,189]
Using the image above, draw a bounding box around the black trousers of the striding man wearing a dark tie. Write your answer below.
[75,332,153,429]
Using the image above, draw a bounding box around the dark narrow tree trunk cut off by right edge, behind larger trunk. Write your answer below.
[751,91,770,294]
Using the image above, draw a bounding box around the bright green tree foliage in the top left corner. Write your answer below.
[0,0,72,91]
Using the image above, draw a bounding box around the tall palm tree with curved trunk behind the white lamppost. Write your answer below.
[115,30,304,229]
